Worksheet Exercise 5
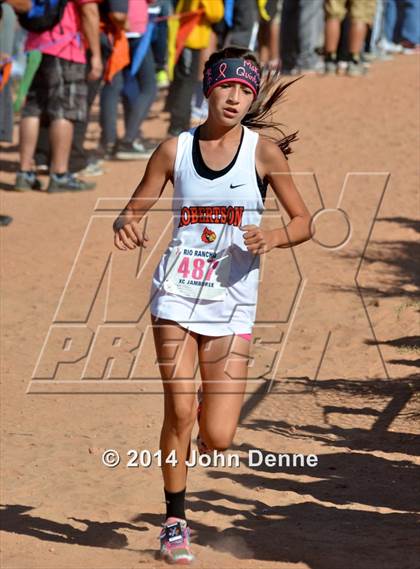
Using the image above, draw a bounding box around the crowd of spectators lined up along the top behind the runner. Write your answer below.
[0,0,420,209]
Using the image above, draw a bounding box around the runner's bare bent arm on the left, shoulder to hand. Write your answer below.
[113,137,178,251]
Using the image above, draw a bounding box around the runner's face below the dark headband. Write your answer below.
[209,81,254,125]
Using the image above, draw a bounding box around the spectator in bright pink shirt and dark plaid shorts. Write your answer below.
[15,0,102,192]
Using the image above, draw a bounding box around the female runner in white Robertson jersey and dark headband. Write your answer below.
[114,46,311,564]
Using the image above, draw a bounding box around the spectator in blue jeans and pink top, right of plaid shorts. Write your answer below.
[100,0,157,160]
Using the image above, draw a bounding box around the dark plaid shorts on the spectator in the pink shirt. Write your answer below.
[22,54,88,122]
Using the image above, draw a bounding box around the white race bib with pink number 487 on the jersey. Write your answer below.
[163,247,231,300]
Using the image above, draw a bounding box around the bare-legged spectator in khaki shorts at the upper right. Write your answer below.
[325,0,376,76]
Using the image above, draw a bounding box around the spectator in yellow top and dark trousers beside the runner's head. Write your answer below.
[167,0,223,136]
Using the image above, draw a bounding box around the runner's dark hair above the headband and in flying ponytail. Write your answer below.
[204,45,300,158]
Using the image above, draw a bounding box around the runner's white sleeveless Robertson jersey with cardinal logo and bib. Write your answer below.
[150,126,264,336]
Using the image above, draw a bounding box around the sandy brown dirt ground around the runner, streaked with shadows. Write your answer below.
[0,55,420,569]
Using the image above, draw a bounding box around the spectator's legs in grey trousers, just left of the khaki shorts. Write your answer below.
[280,0,324,75]
